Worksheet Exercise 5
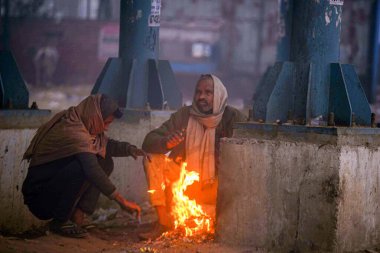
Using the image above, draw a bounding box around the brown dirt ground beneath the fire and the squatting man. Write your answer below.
[0,211,257,253]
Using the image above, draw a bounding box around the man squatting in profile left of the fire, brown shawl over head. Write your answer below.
[22,94,150,238]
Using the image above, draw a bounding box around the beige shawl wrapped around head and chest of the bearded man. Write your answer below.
[186,75,228,186]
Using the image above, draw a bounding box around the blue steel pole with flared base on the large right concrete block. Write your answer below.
[253,0,371,126]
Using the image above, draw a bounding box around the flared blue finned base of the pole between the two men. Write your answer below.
[91,58,182,110]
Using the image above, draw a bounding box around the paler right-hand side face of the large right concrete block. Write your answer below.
[337,146,380,250]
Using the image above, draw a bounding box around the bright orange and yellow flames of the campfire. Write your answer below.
[171,163,214,236]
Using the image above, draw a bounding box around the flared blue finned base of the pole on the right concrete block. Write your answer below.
[253,62,371,126]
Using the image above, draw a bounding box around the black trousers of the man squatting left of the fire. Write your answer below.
[22,155,113,221]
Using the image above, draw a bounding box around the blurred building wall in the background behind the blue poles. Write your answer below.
[3,0,380,105]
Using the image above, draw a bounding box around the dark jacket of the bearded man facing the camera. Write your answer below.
[142,106,247,162]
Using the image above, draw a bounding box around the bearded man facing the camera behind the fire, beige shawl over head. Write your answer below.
[140,74,247,239]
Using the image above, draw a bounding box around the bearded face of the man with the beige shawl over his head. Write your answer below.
[194,79,214,114]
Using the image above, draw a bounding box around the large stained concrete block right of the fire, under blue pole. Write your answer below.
[216,127,380,252]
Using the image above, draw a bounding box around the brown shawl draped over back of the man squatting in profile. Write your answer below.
[23,94,107,166]
